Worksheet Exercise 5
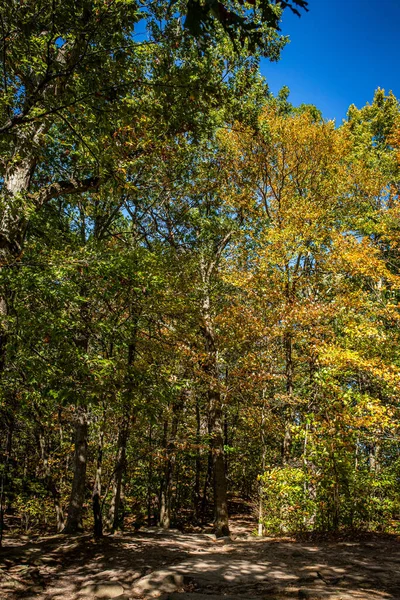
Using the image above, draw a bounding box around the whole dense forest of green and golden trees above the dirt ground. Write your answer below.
[0,0,400,598]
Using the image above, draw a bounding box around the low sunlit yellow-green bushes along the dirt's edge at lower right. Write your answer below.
[260,454,400,535]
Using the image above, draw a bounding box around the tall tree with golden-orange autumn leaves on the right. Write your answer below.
[219,107,398,528]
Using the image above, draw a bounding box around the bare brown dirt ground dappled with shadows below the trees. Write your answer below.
[0,516,400,600]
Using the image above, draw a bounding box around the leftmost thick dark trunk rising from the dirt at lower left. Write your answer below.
[63,410,88,533]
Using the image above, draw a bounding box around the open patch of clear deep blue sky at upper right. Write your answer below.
[261,0,400,124]
